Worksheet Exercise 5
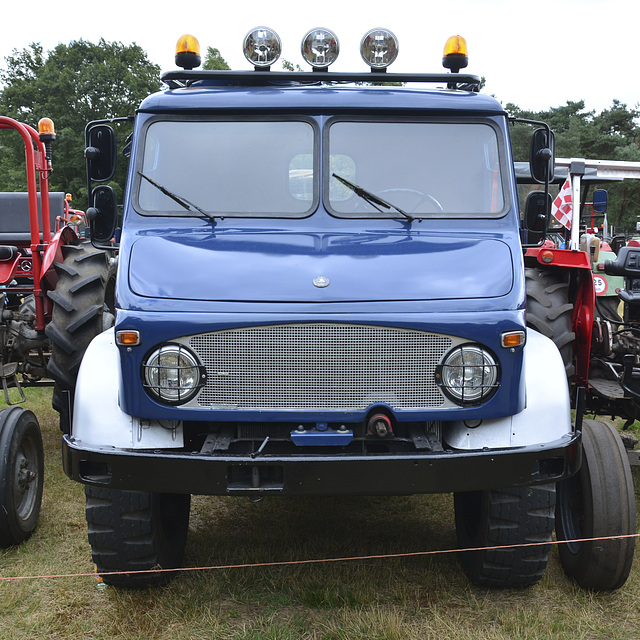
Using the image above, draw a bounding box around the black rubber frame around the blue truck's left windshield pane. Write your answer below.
[131,114,321,219]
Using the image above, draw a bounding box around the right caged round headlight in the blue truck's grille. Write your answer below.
[436,344,498,404]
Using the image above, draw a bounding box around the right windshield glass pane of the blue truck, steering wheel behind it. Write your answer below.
[325,121,505,218]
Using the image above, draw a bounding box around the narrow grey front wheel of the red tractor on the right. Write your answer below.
[556,420,636,591]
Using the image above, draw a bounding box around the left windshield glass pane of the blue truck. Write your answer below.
[136,120,318,217]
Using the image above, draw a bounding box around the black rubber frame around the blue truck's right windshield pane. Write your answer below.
[322,115,512,222]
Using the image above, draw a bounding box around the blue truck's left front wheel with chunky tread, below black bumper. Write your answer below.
[85,485,191,587]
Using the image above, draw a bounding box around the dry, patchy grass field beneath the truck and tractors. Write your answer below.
[0,390,640,640]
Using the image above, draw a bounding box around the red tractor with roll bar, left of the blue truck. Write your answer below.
[0,116,115,547]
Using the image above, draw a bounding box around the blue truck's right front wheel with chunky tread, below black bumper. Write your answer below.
[454,485,555,588]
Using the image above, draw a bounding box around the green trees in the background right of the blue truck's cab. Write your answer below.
[505,100,640,231]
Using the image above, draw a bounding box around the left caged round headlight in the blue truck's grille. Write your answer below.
[143,344,206,404]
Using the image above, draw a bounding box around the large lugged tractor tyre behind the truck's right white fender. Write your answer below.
[525,269,576,379]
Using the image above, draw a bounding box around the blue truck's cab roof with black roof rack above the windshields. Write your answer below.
[140,71,505,115]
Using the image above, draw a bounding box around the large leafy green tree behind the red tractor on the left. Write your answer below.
[0,39,161,208]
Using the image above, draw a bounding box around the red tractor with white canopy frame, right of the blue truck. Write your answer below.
[519,158,640,590]
